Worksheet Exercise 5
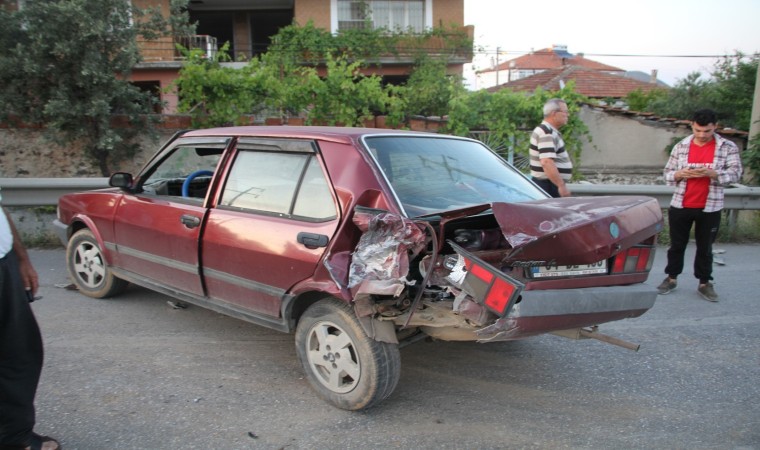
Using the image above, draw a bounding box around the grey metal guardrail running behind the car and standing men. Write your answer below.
[0,178,760,210]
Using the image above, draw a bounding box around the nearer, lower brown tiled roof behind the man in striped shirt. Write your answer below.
[488,66,662,98]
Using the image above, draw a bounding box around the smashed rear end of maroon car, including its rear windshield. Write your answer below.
[312,136,662,409]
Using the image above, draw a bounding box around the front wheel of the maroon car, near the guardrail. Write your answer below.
[66,228,129,298]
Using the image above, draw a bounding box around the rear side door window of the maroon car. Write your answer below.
[221,151,336,221]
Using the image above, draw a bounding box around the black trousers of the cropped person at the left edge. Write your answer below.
[0,251,43,448]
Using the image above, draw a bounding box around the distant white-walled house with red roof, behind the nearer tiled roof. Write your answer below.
[475,45,625,89]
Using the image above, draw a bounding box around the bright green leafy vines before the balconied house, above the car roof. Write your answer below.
[173,22,464,127]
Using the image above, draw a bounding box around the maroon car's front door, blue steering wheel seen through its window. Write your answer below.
[109,138,229,295]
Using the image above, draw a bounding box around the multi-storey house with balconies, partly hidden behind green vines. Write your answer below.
[131,0,473,113]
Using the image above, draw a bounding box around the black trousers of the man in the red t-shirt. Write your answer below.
[665,206,720,283]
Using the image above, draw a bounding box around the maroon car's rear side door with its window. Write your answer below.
[202,138,339,317]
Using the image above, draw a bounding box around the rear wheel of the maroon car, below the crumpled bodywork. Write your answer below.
[296,298,401,411]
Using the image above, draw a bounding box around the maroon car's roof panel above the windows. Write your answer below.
[182,125,440,142]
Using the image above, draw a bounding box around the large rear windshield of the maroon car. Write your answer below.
[364,136,547,217]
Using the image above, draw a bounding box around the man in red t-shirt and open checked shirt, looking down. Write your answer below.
[657,109,742,302]
